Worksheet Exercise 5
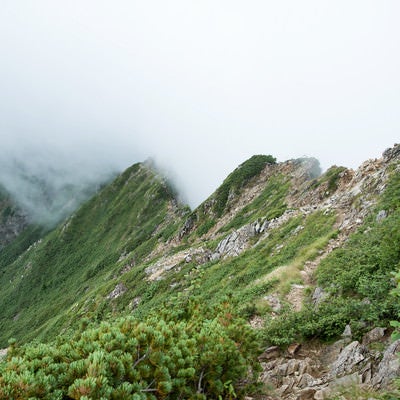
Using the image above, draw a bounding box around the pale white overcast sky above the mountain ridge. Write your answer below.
[0,0,400,206]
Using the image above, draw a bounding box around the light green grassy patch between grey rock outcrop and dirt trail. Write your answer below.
[173,209,336,314]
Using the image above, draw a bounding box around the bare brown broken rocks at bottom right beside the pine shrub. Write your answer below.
[259,328,400,400]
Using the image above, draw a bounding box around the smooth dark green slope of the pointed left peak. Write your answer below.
[0,164,186,345]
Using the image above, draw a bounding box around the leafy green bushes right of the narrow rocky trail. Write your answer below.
[265,167,400,345]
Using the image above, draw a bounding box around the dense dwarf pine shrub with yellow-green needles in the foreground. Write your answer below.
[0,300,260,400]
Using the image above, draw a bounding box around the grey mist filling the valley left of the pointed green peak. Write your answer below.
[0,142,119,228]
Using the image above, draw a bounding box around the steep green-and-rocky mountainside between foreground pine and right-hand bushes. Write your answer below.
[1,148,397,346]
